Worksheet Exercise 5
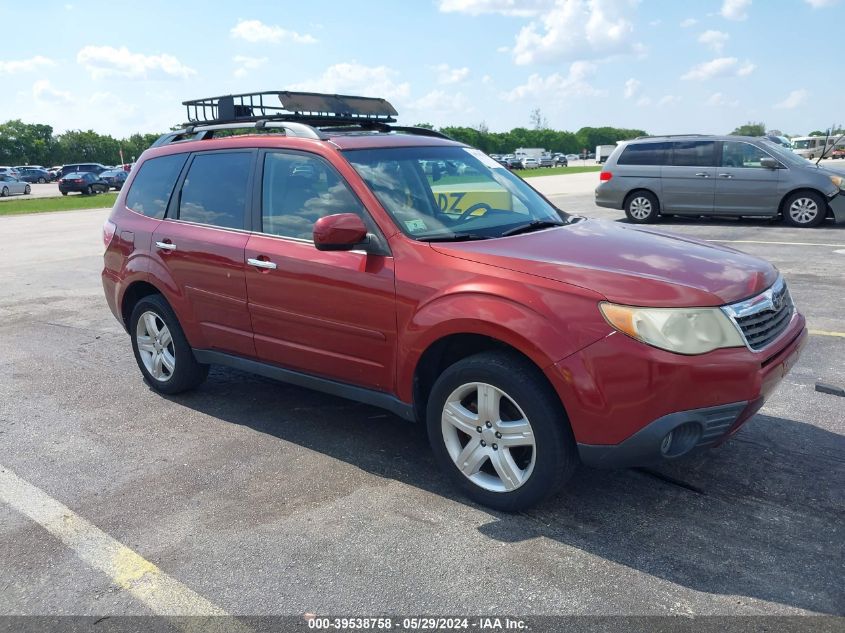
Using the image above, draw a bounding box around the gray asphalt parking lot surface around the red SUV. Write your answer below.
[0,181,845,616]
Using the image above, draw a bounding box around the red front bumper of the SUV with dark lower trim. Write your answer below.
[547,313,807,467]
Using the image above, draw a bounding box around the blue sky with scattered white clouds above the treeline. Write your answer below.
[0,0,845,136]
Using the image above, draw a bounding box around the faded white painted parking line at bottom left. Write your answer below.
[0,465,251,632]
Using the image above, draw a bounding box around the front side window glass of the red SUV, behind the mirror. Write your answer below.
[261,152,366,240]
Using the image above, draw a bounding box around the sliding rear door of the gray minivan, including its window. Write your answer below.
[661,140,716,215]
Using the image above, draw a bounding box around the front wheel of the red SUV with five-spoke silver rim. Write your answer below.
[426,352,578,512]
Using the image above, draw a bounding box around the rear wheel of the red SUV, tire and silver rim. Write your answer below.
[129,295,208,394]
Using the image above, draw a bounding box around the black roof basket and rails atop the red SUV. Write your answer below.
[152,90,449,147]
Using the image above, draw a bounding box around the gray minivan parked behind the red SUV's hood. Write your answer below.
[596,135,845,227]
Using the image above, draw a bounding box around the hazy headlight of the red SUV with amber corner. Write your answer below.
[599,302,745,354]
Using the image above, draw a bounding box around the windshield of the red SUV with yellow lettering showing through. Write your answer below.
[344,147,568,241]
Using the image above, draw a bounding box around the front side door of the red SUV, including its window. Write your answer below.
[241,151,396,391]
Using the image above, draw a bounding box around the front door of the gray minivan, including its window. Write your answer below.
[714,141,782,215]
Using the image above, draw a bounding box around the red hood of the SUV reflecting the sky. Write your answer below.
[431,220,777,307]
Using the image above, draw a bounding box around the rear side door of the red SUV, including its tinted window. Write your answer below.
[151,150,256,357]
